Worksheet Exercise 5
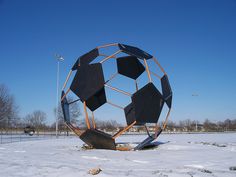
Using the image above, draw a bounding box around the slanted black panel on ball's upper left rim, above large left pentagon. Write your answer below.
[72,48,99,71]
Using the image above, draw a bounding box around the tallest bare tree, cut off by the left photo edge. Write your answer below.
[0,84,17,128]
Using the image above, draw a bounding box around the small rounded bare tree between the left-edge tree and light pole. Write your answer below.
[24,110,47,133]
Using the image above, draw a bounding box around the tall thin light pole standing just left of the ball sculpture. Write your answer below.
[55,54,64,137]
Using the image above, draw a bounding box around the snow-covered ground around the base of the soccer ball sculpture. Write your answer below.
[0,133,236,177]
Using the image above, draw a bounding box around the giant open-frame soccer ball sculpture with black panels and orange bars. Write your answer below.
[61,43,172,150]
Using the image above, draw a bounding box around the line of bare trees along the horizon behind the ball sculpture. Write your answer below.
[0,84,236,132]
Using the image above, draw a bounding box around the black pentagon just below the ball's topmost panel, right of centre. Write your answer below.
[116,56,145,80]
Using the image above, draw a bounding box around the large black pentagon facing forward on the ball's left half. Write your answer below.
[70,63,104,102]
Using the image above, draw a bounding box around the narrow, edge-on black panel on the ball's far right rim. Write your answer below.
[161,75,172,108]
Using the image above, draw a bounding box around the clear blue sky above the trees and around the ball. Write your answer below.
[0,0,236,124]
